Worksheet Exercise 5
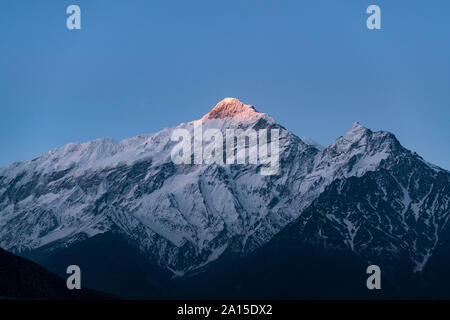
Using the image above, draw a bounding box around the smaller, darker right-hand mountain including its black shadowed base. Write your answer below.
[173,123,450,299]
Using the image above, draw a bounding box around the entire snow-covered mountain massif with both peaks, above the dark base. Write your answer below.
[0,98,450,297]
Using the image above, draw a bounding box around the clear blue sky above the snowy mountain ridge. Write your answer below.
[0,0,450,169]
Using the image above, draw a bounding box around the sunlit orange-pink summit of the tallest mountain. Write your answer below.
[202,98,263,120]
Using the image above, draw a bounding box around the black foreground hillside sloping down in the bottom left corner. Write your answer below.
[0,249,117,300]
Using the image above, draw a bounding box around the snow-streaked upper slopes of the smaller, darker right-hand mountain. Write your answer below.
[272,125,450,272]
